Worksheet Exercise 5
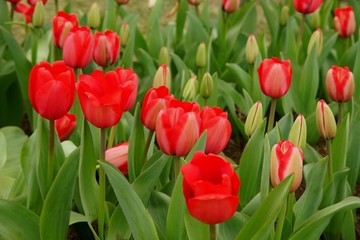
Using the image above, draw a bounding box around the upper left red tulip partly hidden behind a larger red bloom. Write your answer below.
[52,11,78,48]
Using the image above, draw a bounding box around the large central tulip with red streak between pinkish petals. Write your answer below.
[155,100,200,156]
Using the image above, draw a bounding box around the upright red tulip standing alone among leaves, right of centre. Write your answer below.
[258,57,292,98]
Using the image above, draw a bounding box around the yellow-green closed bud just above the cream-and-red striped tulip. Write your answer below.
[289,114,306,149]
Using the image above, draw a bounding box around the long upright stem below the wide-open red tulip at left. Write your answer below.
[98,128,106,239]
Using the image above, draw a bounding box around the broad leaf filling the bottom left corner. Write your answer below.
[0,199,40,240]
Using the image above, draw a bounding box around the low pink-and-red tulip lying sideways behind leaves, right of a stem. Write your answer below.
[105,142,129,175]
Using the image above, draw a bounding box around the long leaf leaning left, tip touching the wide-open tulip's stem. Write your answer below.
[100,162,158,240]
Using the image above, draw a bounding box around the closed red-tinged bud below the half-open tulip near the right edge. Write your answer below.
[316,100,336,140]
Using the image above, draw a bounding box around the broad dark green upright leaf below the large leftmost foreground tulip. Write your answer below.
[40,150,79,240]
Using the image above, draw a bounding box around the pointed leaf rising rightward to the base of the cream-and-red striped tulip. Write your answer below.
[236,175,294,240]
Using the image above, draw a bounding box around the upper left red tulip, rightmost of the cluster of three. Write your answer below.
[93,30,120,67]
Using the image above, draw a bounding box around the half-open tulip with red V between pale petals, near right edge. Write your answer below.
[326,66,355,102]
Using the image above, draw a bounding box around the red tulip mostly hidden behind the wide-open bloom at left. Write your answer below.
[115,67,139,111]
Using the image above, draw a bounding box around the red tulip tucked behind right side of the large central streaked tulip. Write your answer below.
[200,106,231,154]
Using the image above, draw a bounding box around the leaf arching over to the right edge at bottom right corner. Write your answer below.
[290,197,360,240]
